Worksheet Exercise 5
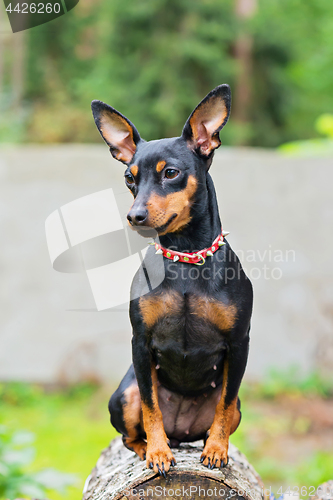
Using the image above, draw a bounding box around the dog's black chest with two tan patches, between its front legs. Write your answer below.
[140,291,236,391]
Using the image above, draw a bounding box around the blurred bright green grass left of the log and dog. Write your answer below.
[0,384,116,500]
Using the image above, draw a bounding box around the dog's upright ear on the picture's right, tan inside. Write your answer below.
[183,84,231,157]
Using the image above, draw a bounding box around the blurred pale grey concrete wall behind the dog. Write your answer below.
[0,145,333,383]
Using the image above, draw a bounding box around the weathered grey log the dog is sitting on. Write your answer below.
[83,437,266,500]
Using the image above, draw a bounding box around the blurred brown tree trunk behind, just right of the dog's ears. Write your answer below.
[233,0,257,145]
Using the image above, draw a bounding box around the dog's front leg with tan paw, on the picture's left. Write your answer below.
[132,331,176,476]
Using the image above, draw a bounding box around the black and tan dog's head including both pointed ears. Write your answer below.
[92,85,231,236]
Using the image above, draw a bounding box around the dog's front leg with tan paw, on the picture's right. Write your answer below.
[201,335,249,469]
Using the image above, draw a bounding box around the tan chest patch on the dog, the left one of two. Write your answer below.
[139,291,183,328]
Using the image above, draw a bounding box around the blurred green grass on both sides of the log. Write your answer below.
[0,374,333,500]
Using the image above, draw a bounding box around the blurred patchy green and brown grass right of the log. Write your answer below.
[230,378,333,498]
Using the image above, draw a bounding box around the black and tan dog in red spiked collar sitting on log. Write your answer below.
[92,85,252,475]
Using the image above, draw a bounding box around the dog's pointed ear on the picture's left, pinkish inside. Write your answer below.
[91,101,141,165]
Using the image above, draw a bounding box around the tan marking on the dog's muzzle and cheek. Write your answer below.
[147,175,197,235]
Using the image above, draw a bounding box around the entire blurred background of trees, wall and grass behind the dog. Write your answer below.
[0,0,333,500]
